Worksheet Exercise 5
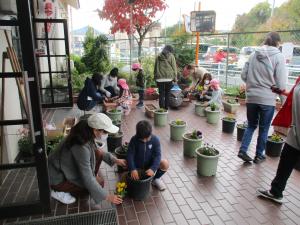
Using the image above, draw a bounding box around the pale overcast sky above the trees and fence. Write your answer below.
[73,0,287,33]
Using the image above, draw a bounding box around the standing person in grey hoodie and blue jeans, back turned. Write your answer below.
[238,32,287,163]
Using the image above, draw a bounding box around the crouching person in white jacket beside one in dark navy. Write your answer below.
[100,67,120,98]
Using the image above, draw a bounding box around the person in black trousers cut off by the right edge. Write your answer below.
[257,83,300,203]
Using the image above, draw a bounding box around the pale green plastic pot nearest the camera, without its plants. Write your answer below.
[196,148,220,177]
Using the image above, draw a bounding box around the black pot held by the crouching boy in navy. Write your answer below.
[126,171,153,201]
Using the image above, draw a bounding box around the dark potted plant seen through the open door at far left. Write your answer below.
[16,128,34,162]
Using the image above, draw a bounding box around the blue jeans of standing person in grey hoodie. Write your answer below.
[240,103,275,157]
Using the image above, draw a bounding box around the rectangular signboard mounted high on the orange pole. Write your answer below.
[191,11,216,32]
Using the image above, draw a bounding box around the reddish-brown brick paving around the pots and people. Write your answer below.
[0,101,300,225]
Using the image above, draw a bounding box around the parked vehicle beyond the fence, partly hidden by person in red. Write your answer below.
[205,45,239,64]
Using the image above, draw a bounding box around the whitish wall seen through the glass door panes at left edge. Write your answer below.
[0,30,21,163]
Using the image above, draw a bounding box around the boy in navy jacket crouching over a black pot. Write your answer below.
[127,120,169,191]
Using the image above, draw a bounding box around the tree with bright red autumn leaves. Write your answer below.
[100,0,167,57]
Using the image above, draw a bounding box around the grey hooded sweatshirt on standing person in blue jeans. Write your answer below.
[241,45,287,106]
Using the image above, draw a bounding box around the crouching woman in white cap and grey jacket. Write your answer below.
[48,113,126,204]
